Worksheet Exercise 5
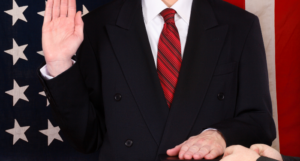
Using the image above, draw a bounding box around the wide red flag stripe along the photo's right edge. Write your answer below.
[275,0,300,157]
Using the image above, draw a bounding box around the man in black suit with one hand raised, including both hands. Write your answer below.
[39,0,276,161]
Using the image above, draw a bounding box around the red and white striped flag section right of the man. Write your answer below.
[225,0,300,157]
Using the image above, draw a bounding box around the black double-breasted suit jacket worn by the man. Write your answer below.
[40,0,276,161]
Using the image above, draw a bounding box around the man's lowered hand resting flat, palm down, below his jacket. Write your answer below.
[167,130,226,160]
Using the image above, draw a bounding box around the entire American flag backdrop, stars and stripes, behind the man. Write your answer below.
[0,0,300,161]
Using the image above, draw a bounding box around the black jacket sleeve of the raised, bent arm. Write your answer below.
[38,25,105,153]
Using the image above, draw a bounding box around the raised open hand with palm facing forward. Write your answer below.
[42,0,84,77]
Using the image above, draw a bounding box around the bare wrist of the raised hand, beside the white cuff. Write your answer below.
[46,59,73,77]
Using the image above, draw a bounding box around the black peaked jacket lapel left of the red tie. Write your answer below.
[106,0,169,145]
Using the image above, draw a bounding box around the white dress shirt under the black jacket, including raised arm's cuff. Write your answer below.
[40,0,193,80]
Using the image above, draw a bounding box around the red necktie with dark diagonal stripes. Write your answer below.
[157,9,182,108]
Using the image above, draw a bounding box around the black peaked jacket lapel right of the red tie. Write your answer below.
[158,0,228,153]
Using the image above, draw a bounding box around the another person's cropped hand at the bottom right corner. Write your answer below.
[221,144,300,161]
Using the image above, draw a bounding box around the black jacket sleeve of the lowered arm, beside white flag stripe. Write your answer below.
[210,17,276,147]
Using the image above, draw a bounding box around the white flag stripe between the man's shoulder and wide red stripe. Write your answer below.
[245,0,279,150]
